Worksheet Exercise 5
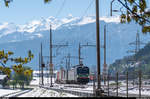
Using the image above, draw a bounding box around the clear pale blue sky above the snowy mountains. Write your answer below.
[0,0,121,24]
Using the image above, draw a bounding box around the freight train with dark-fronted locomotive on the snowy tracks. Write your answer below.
[56,64,89,84]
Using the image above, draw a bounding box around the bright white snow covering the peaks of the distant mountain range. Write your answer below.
[0,14,120,37]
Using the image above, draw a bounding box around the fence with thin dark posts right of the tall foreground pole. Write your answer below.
[105,71,150,98]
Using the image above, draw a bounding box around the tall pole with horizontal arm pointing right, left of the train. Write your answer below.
[50,25,68,87]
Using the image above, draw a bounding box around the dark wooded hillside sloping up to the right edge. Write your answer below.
[109,43,150,78]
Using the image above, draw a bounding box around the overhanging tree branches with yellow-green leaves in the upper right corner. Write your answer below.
[114,0,150,33]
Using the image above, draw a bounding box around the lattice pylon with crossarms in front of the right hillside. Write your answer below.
[127,31,145,86]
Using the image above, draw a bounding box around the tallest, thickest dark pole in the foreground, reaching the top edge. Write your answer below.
[96,0,102,96]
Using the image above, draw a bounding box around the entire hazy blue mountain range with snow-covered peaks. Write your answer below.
[0,15,150,69]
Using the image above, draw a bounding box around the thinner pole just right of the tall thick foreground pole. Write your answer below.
[103,25,107,85]
